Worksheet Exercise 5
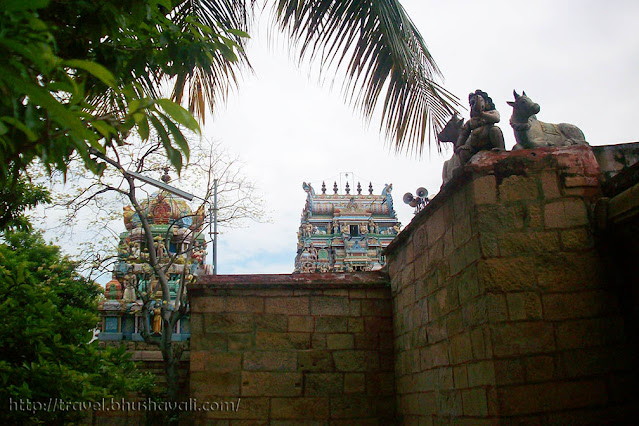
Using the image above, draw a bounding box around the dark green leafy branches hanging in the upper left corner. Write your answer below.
[0,0,250,183]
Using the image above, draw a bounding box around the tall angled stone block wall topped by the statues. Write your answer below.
[387,147,636,424]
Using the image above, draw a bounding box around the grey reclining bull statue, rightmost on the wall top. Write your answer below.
[506,90,588,150]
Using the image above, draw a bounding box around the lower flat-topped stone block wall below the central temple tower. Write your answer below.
[189,272,395,425]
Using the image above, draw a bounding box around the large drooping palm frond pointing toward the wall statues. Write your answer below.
[276,0,460,152]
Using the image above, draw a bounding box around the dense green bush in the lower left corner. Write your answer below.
[0,233,148,424]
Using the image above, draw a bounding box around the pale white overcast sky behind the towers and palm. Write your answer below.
[40,0,639,279]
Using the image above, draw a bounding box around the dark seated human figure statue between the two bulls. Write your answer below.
[455,89,505,164]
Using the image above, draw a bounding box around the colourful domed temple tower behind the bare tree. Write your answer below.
[98,175,211,341]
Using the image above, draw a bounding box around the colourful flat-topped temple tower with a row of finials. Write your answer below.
[295,182,401,273]
